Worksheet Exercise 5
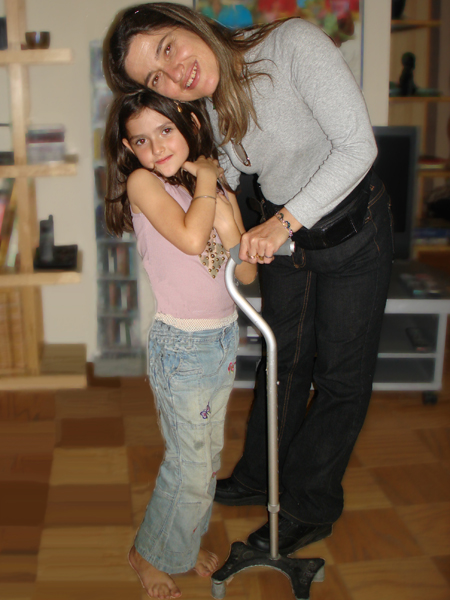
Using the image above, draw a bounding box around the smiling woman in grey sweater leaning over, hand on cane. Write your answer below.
[106,3,393,554]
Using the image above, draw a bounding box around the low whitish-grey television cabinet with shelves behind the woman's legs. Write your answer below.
[235,261,450,403]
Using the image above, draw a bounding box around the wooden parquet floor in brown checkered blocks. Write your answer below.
[0,360,450,600]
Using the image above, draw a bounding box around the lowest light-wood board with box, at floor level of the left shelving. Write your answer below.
[0,344,87,391]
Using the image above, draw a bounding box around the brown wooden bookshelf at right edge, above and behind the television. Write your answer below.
[389,0,450,266]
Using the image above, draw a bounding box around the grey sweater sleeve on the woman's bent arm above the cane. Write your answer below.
[276,19,377,227]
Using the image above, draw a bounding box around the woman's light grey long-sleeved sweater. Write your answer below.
[207,19,377,228]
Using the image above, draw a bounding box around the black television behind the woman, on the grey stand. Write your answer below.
[373,126,419,260]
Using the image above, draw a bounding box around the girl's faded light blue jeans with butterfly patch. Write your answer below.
[135,321,239,573]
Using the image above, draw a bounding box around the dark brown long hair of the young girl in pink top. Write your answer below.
[104,89,218,237]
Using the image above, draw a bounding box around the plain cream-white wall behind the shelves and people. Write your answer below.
[0,0,390,360]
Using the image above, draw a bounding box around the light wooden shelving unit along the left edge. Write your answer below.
[0,0,86,390]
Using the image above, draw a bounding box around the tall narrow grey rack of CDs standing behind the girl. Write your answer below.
[90,41,145,377]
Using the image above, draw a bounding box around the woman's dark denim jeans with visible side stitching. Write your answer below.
[233,174,393,524]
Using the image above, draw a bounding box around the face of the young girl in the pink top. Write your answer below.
[122,108,189,177]
